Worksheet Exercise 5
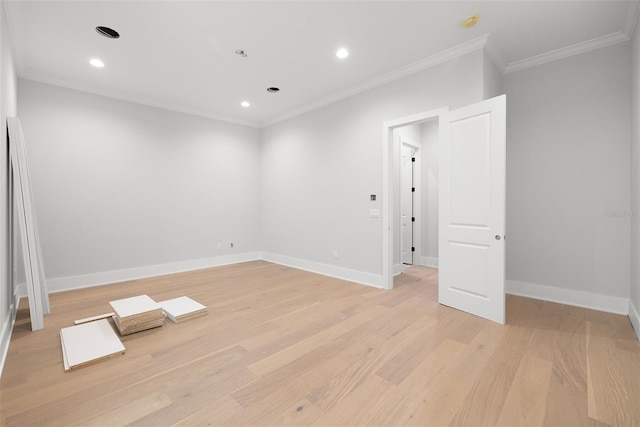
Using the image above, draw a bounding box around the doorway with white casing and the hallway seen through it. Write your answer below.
[382,108,449,289]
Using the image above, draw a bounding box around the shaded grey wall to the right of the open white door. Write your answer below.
[504,44,637,312]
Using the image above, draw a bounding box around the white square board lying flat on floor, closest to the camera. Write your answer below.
[60,319,125,371]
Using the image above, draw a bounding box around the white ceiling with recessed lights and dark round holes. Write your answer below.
[6,0,638,126]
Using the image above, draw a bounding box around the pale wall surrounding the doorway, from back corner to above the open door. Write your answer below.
[260,51,483,284]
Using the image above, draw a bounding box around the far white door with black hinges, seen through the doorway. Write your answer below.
[400,144,414,265]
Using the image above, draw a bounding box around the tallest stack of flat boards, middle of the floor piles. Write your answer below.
[109,295,165,335]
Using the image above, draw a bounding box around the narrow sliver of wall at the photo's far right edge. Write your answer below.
[629,28,640,339]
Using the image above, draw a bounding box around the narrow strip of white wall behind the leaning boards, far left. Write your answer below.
[0,1,16,372]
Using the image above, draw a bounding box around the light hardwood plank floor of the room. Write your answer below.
[0,261,640,426]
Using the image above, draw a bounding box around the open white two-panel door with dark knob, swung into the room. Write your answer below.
[438,95,506,323]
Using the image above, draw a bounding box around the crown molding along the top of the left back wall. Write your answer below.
[18,71,260,128]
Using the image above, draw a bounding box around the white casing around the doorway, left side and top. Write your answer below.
[382,107,449,289]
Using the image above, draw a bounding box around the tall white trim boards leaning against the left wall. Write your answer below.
[7,117,51,331]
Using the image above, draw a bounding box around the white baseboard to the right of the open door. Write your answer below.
[505,280,629,315]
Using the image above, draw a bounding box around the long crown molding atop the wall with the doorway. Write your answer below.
[261,34,489,127]
